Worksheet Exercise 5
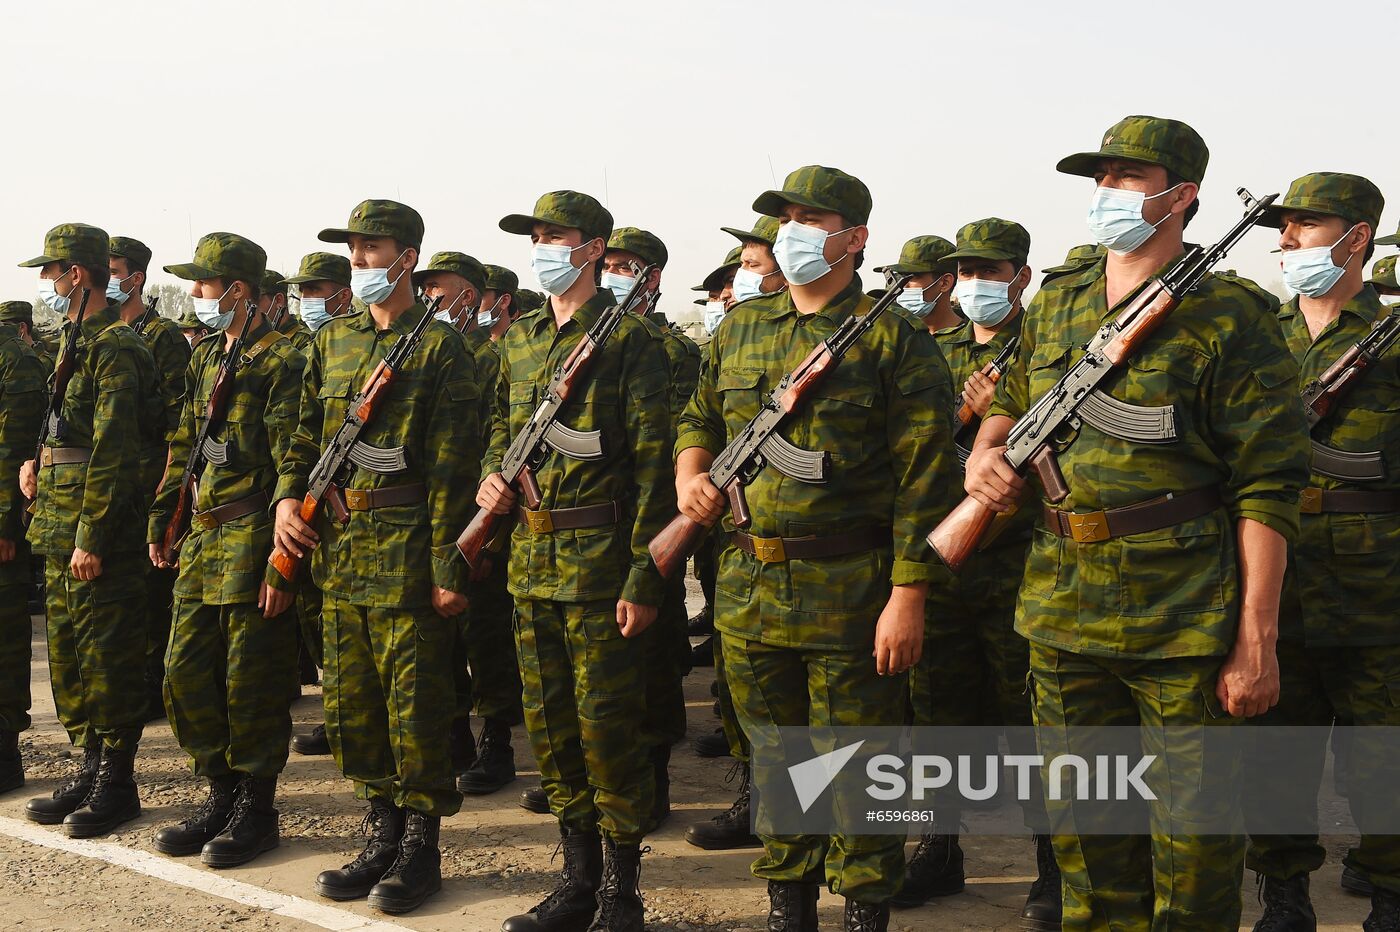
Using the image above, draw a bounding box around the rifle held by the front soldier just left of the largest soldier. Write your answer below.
[648,268,913,578]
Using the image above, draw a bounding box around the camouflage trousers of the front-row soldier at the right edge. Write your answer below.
[1245,640,1400,893]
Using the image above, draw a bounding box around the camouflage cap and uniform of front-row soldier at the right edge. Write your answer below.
[1247,172,1400,891]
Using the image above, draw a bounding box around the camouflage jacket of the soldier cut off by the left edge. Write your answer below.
[0,323,48,588]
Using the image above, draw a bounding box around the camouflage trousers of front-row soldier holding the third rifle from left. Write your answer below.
[321,593,462,816]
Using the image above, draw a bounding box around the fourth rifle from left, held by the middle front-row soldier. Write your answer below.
[456,263,657,570]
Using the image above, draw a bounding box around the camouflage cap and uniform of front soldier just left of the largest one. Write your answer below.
[676,167,956,904]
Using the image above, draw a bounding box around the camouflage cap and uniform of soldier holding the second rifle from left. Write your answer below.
[147,234,305,779]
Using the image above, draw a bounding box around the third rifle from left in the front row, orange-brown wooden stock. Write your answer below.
[267,298,442,582]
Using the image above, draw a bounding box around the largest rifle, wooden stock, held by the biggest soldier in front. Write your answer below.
[928,188,1278,572]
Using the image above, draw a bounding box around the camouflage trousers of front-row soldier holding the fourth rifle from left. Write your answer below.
[515,599,655,845]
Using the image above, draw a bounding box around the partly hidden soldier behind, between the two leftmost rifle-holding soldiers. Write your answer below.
[106,236,190,719]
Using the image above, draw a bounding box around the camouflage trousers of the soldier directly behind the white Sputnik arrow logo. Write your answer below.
[720,633,909,903]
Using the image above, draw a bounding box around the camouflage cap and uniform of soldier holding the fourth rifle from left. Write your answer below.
[482,192,675,845]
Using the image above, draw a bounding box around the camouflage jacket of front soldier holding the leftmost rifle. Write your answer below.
[29,305,164,559]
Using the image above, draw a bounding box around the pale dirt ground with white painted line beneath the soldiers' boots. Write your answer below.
[0,590,1368,932]
